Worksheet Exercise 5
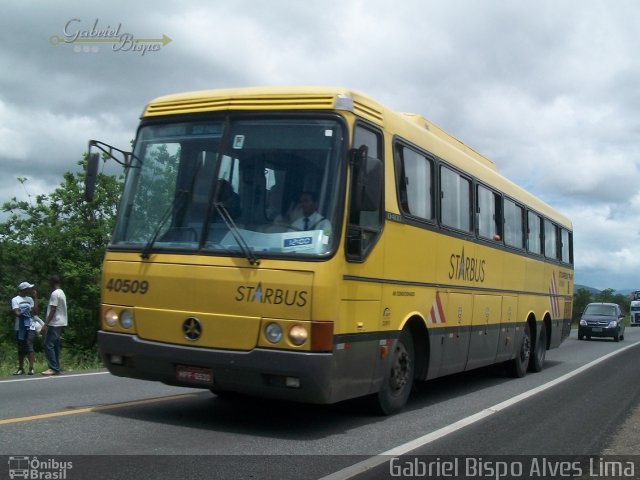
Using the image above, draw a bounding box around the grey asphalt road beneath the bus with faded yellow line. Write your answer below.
[0,329,640,480]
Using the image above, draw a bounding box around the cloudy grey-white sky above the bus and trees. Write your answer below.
[0,0,640,290]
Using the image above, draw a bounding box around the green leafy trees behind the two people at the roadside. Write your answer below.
[0,157,122,348]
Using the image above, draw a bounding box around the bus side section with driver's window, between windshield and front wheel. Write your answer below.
[336,125,387,398]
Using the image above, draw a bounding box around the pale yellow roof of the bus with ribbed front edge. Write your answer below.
[142,87,572,230]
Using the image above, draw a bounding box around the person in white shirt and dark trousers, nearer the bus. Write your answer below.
[42,275,68,375]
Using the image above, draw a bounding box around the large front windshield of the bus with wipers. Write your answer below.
[111,115,346,263]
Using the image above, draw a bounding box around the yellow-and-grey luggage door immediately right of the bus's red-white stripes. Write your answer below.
[438,293,473,376]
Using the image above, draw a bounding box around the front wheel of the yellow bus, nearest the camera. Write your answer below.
[376,330,415,415]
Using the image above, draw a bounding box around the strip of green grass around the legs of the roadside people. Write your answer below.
[0,339,103,377]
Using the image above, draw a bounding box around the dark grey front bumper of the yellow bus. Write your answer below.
[98,331,339,403]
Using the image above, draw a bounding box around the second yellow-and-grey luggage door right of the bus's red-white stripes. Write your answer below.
[466,295,502,370]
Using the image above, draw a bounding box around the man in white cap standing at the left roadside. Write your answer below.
[11,282,38,375]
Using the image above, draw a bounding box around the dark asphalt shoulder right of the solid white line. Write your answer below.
[350,348,640,480]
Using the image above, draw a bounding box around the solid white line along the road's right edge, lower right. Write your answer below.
[320,343,640,480]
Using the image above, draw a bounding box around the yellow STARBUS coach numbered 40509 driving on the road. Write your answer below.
[87,87,573,414]
